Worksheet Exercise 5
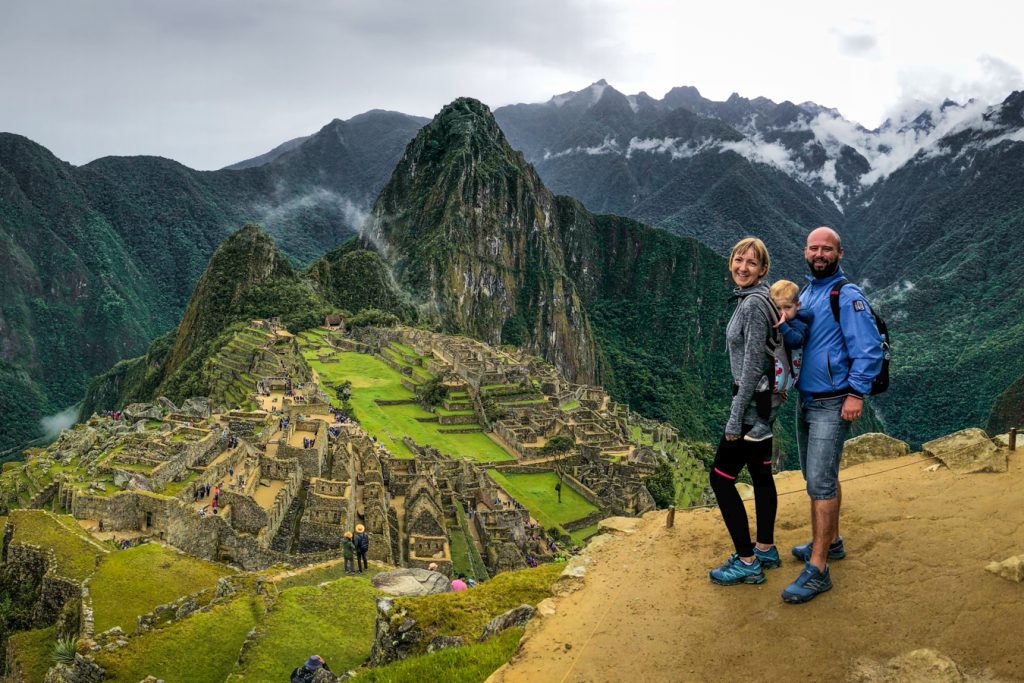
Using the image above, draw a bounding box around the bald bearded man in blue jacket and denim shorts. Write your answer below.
[782,227,884,603]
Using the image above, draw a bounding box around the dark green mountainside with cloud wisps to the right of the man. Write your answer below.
[848,93,1024,441]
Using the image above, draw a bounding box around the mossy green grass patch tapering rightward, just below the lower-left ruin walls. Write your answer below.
[90,543,233,633]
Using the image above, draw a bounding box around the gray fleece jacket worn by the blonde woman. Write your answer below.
[725,284,777,436]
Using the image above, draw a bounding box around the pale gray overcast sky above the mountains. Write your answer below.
[0,0,1024,169]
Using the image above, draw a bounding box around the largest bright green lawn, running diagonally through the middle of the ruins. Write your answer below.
[300,336,513,462]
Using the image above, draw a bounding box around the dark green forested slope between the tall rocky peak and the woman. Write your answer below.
[556,197,731,435]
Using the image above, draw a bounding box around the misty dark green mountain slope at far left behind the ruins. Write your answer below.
[0,112,423,452]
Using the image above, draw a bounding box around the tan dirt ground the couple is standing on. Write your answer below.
[488,451,1024,683]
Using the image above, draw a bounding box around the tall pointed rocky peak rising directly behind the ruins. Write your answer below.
[369,98,598,382]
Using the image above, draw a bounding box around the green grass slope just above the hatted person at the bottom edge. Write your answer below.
[229,575,381,683]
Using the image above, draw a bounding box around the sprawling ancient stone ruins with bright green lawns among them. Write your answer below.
[2,321,699,580]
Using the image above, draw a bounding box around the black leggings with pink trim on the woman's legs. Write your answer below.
[711,425,778,557]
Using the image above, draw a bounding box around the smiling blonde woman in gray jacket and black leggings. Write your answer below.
[709,238,781,586]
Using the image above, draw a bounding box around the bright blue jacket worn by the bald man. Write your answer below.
[797,269,883,399]
